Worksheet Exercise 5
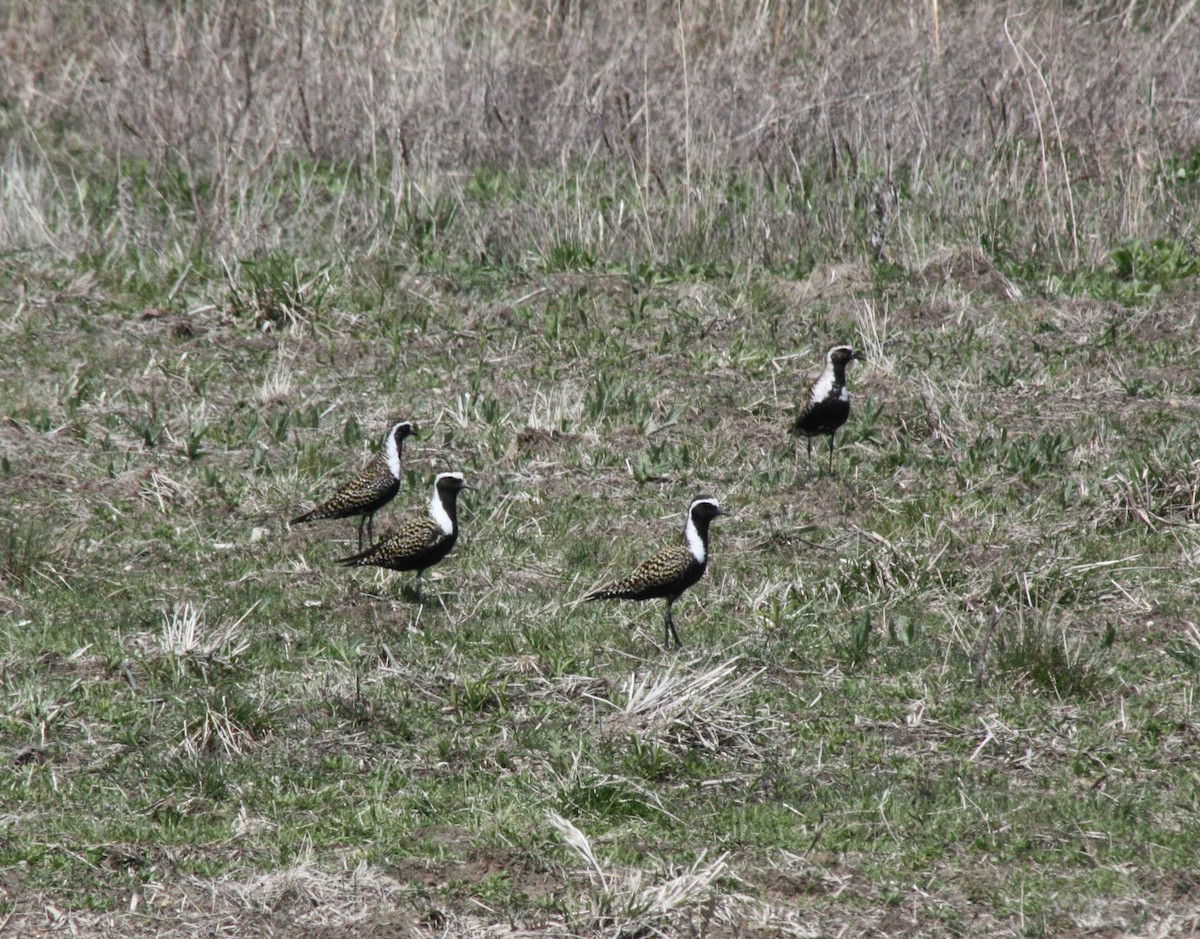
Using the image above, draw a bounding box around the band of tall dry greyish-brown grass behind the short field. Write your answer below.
[7,0,1200,267]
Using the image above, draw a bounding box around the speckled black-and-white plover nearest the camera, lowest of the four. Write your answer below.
[586,496,726,648]
